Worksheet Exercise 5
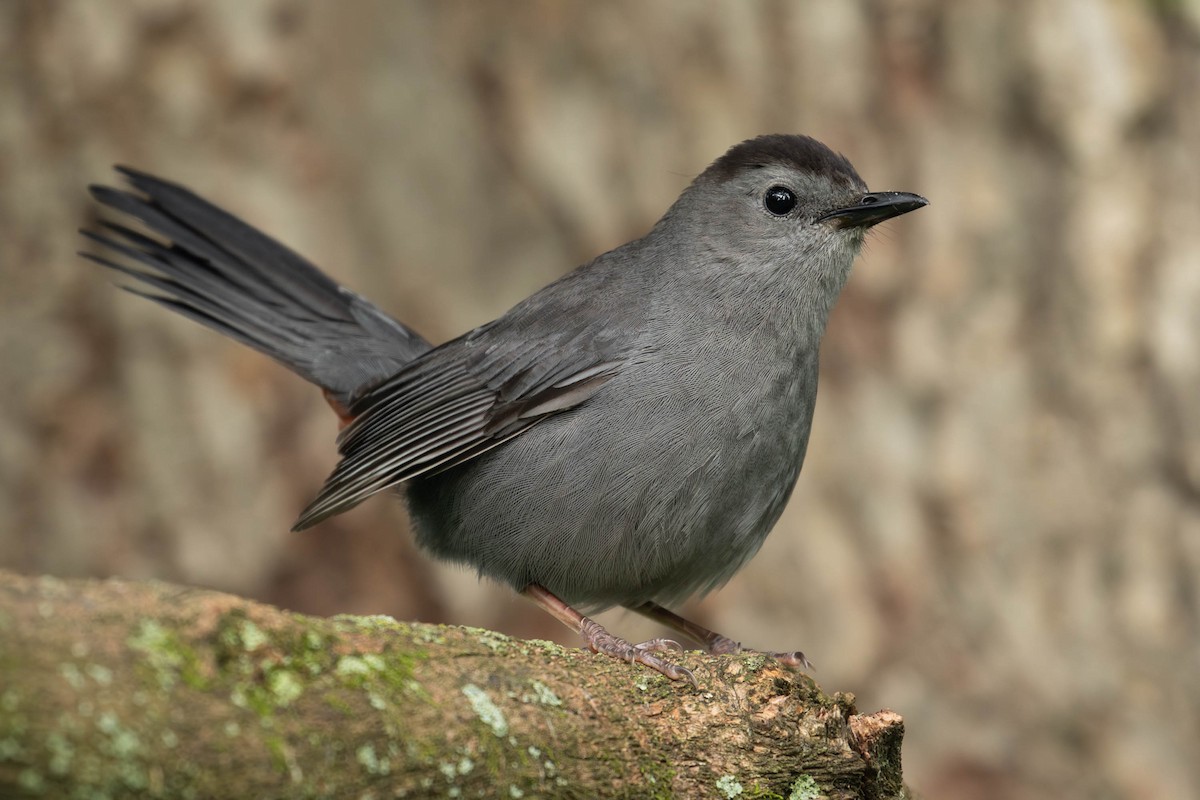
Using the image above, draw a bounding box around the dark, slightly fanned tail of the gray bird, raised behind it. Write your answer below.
[80,167,430,403]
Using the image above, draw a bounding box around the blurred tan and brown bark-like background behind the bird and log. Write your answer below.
[0,0,1200,800]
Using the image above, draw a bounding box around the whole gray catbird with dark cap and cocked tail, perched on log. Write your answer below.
[84,136,926,685]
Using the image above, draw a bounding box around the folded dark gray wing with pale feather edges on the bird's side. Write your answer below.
[293,324,628,530]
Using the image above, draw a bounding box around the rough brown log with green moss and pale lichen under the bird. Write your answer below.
[0,572,905,799]
